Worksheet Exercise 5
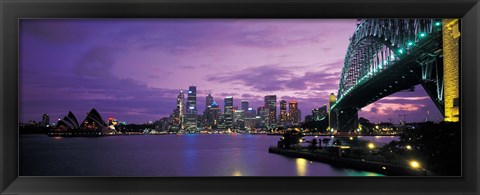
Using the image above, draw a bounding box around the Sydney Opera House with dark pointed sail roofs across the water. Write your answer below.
[48,108,110,136]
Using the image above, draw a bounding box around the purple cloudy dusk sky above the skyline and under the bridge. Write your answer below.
[20,19,443,123]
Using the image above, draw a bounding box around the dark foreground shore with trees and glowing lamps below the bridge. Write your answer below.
[268,122,461,176]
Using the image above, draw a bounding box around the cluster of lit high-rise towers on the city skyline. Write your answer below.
[166,86,308,132]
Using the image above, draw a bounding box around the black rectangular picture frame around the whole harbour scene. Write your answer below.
[0,0,480,194]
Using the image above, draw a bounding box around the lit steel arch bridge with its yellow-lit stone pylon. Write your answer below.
[329,19,460,132]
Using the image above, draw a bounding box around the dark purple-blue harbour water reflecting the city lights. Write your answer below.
[19,134,397,176]
